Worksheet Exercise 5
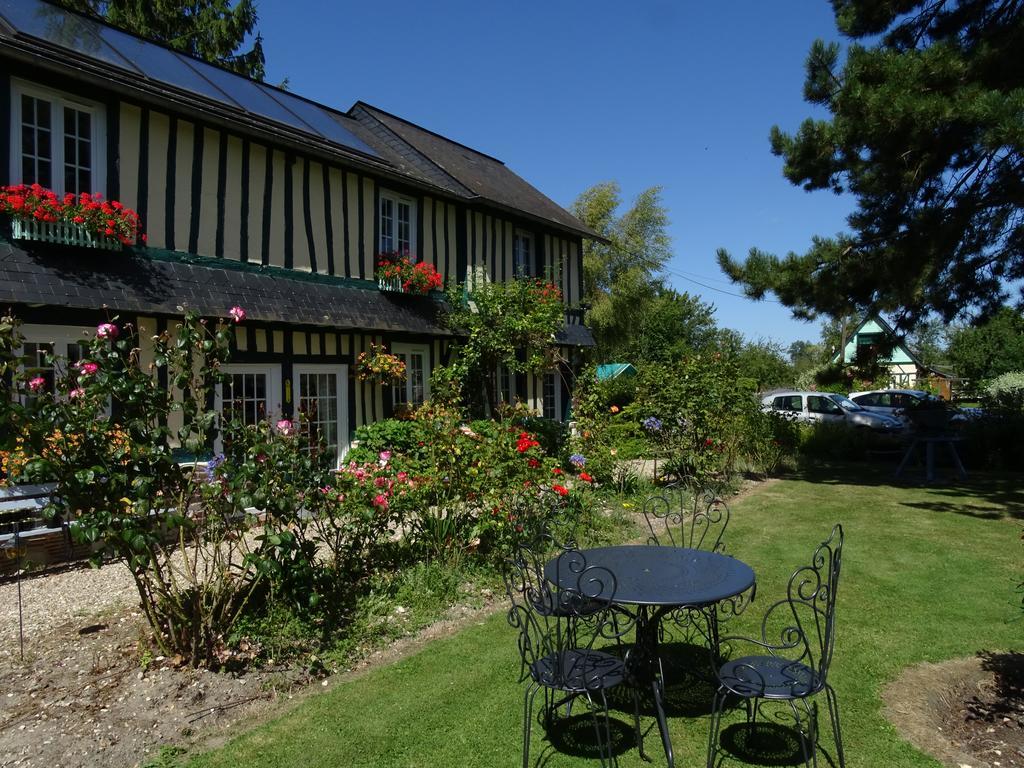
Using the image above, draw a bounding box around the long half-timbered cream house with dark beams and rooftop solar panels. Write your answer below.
[0,0,594,456]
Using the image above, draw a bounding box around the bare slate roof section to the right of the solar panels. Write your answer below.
[349,101,600,239]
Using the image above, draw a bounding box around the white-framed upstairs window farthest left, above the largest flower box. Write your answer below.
[10,80,106,195]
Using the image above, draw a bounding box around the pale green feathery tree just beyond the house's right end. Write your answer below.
[571,181,672,359]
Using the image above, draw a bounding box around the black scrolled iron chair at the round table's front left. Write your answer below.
[505,546,643,768]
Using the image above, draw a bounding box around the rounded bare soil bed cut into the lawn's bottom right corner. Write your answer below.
[883,653,1024,768]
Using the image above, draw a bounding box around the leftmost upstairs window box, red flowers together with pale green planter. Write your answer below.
[0,184,145,250]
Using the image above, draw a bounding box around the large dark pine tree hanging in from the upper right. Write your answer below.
[718,0,1024,330]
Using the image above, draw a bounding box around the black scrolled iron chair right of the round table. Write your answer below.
[708,524,846,768]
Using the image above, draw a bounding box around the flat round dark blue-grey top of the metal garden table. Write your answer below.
[544,545,754,605]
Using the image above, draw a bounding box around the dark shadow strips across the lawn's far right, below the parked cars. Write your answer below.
[774,462,1024,520]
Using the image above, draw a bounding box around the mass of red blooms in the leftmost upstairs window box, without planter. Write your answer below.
[0,184,145,246]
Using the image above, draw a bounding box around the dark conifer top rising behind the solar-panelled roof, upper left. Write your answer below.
[58,0,265,80]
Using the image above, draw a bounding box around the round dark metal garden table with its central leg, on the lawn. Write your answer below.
[545,545,755,768]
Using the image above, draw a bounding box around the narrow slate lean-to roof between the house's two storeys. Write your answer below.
[0,240,452,336]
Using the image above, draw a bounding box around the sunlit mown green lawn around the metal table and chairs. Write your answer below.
[189,465,1024,768]
